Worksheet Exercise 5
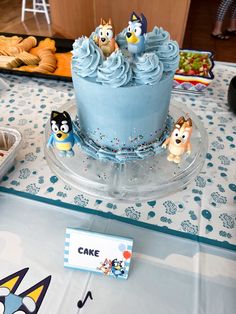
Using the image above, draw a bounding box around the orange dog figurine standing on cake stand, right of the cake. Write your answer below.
[162,117,192,164]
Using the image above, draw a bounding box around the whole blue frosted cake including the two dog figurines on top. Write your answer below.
[72,12,179,162]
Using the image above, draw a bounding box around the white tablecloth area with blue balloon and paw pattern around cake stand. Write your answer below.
[0,64,236,250]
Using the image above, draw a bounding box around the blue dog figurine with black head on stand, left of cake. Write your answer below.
[47,111,80,157]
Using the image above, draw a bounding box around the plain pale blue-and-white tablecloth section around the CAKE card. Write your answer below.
[0,193,236,314]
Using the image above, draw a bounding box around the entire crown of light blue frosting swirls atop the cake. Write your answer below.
[72,26,179,87]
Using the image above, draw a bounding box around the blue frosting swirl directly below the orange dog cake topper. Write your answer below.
[97,50,132,87]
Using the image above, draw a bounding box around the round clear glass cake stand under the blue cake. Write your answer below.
[45,99,207,202]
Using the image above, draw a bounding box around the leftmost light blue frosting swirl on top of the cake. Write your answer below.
[72,37,103,77]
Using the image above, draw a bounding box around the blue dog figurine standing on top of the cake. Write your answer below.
[126,12,147,55]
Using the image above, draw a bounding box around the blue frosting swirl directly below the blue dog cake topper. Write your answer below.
[133,53,163,85]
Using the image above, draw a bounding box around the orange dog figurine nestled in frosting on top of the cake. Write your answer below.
[93,18,119,57]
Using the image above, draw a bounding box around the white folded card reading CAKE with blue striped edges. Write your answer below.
[64,228,133,279]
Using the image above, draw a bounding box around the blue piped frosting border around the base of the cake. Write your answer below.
[73,115,174,163]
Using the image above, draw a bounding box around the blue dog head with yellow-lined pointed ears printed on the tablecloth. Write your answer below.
[0,268,51,314]
